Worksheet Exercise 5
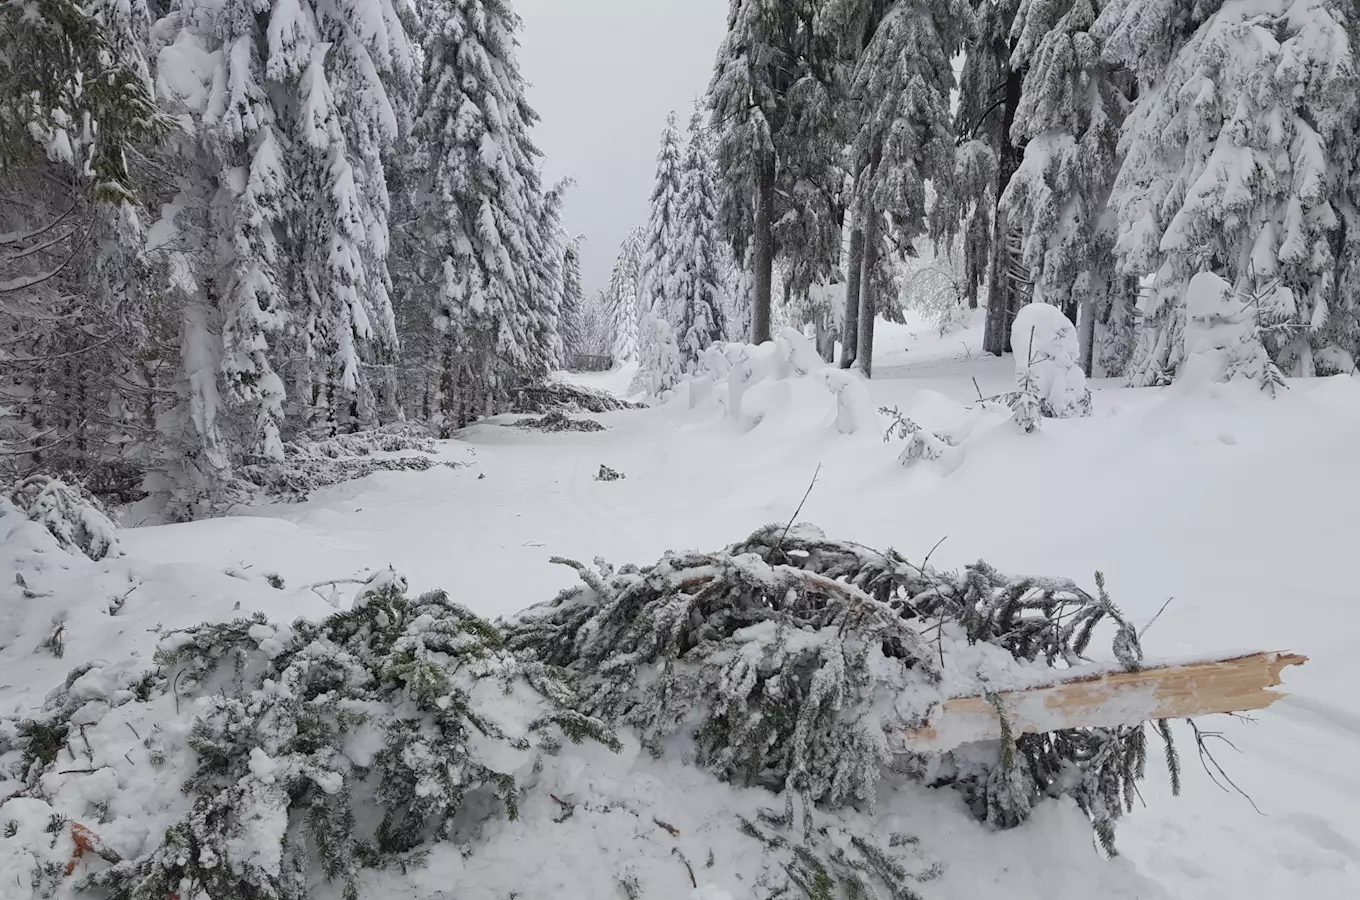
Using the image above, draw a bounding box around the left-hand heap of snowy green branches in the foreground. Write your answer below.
[18,571,617,900]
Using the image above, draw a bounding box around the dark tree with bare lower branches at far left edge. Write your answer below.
[0,0,169,494]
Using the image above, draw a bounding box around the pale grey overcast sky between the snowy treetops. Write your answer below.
[513,0,728,301]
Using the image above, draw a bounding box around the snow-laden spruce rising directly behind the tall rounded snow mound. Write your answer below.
[1001,0,1130,374]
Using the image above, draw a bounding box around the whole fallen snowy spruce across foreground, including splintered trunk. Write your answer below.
[0,522,1302,900]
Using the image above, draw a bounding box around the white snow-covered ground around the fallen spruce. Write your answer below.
[0,314,1360,900]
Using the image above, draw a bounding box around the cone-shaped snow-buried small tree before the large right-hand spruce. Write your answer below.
[1176,272,1282,387]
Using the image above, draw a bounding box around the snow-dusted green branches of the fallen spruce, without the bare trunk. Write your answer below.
[7,525,1180,900]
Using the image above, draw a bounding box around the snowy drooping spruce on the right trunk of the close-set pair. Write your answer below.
[853,0,967,375]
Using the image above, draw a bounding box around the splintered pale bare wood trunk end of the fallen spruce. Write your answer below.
[903,651,1308,753]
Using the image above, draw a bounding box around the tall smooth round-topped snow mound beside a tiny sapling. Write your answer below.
[1010,303,1091,419]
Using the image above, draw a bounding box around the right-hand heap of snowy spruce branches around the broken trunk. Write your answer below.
[505,525,1178,850]
